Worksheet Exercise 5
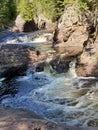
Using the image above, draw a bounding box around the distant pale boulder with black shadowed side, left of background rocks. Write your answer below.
[13,15,38,32]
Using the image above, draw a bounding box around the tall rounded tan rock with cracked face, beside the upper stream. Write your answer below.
[54,5,88,56]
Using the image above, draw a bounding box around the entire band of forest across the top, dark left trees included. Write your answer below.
[0,0,98,28]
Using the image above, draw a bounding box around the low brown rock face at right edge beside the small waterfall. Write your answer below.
[76,41,98,77]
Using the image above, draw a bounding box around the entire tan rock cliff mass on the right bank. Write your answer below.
[53,5,98,77]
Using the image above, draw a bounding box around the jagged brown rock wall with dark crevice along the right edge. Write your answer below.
[76,11,98,77]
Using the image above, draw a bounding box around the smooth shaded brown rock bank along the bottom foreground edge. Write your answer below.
[0,105,98,130]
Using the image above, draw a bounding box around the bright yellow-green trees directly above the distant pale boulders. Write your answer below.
[18,0,56,21]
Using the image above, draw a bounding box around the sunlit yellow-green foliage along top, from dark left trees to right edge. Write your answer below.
[18,0,98,21]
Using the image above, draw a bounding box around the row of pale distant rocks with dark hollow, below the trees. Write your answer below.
[13,14,55,32]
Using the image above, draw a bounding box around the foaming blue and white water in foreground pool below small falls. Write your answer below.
[1,32,98,126]
